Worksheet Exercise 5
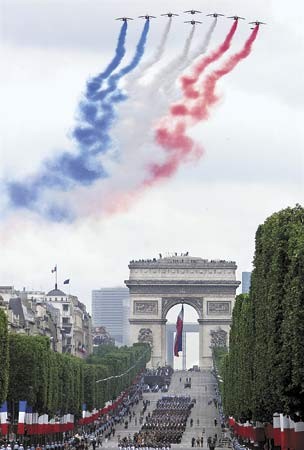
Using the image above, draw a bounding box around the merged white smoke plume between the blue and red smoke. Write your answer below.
[46,21,220,216]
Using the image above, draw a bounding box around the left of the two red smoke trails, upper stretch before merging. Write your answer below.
[181,20,238,99]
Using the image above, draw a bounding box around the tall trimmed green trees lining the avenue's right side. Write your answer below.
[223,205,304,421]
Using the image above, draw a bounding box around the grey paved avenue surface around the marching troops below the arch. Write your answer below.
[102,370,227,450]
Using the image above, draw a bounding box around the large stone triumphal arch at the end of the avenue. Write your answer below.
[125,254,240,368]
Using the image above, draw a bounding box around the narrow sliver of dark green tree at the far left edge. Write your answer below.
[0,309,9,405]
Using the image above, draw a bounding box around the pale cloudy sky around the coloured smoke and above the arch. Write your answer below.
[0,0,304,316]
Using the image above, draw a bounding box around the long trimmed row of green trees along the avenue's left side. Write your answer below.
[0,326,151,417]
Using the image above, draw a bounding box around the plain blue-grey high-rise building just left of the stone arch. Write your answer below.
[92,287,129,345]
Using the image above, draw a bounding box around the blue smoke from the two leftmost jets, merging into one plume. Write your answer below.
[7,21,149,222]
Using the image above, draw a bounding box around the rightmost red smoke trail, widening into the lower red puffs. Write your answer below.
[142,26,259,187]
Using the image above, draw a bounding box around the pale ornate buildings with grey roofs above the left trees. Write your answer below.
[0,285,93,358]
